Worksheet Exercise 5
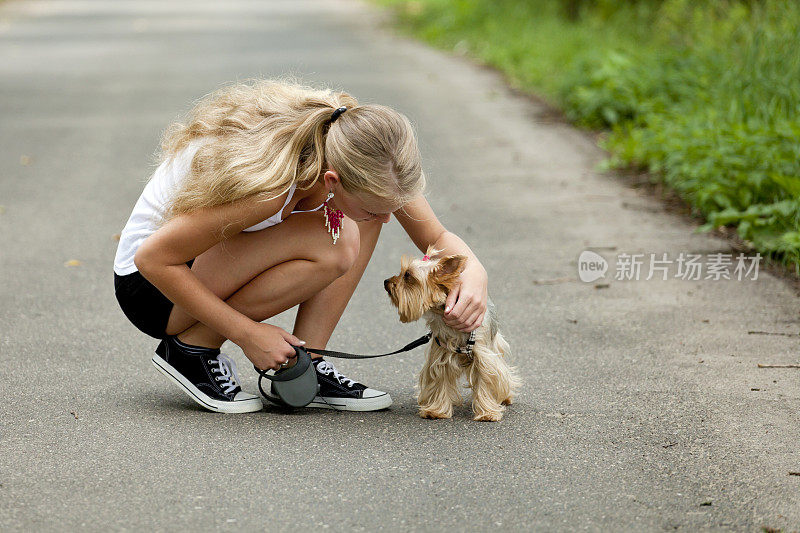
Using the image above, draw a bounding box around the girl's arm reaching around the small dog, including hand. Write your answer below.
[394,196,489,333]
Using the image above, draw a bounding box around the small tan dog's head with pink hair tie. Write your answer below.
[383,246,467,322]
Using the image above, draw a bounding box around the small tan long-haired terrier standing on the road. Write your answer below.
[383,247,521,421]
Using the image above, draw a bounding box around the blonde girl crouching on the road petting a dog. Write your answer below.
[114,78,487,413]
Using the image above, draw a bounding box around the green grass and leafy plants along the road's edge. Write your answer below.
[373,0,800,273]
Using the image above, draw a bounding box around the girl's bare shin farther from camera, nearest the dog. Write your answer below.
[292,221,383,357]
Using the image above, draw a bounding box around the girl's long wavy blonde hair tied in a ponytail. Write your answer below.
[152,77,426,221]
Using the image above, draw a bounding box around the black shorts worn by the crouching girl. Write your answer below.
[114,259,194,339]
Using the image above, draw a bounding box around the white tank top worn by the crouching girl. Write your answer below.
[114,139,324,276]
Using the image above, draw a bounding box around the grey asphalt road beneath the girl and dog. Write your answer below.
[0,0,800,531]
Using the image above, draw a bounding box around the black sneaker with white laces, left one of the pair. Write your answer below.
[153,336,263,413]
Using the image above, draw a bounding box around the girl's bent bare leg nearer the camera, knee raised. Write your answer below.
[166,212,359,348]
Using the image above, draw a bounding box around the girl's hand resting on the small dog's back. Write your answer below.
[444,260,489,333]
